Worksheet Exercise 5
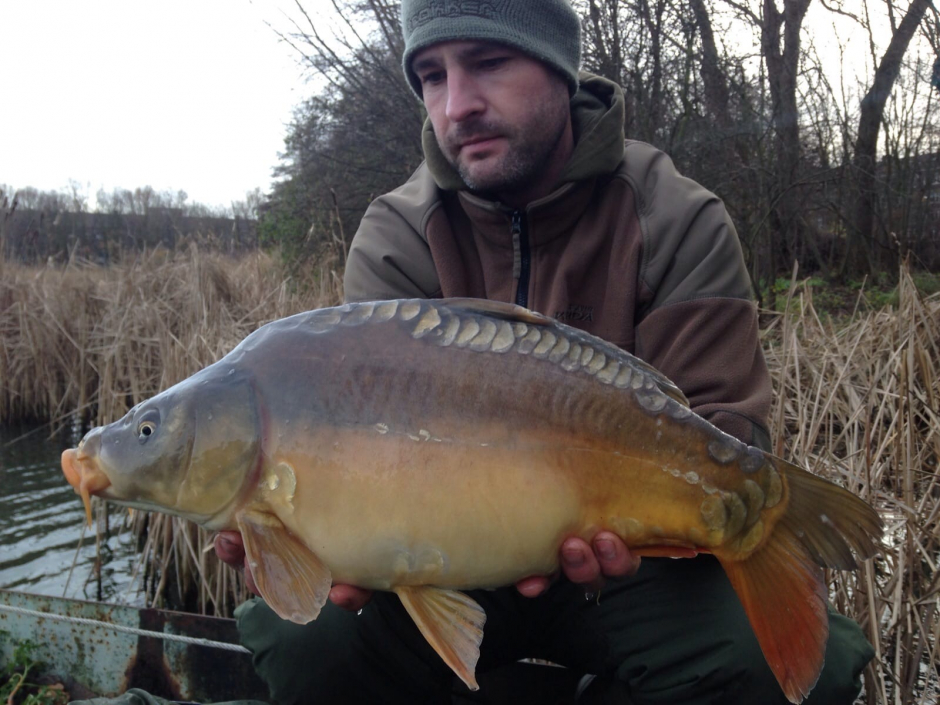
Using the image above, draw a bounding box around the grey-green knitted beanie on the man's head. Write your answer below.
[401,0,581,97]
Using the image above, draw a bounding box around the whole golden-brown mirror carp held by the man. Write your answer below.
[62,299,882,703]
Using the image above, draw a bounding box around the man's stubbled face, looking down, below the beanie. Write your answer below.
[411,41,571,193]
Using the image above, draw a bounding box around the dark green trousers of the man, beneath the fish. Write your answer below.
[236,556,874,705]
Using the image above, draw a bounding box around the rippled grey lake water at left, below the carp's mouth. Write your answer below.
[0,425,142,604]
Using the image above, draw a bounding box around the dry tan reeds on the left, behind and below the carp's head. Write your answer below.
[0,247,341,615]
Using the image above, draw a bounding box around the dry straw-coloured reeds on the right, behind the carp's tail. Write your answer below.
[765,269,940,705]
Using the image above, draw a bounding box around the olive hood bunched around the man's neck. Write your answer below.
[421,71,624,191]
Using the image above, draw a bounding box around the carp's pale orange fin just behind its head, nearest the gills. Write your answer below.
[235,510,333,624]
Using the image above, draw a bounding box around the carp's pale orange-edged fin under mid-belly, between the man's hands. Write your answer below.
[395,586,486,690]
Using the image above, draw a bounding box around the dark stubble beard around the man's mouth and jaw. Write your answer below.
[441,95,569,193]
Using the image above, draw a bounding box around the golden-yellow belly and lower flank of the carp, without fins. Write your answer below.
[260,429,705,589]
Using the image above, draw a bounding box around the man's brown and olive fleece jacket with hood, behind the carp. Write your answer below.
[345,74,771,447]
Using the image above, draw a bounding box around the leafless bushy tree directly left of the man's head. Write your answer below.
[260,0,424,266]
